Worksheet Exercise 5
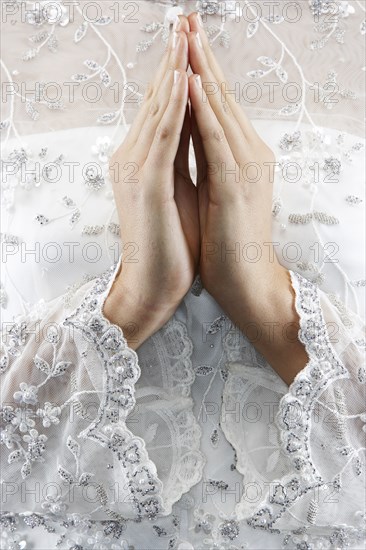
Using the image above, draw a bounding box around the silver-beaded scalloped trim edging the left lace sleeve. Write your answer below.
[64,266,206,519]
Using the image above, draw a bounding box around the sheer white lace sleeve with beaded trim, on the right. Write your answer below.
[222,272,366,548]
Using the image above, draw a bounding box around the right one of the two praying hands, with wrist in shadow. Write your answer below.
[188,14,307,383]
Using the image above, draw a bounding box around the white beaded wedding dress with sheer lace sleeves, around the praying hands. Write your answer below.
[0,0,366,550]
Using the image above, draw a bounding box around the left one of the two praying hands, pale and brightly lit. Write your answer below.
[103,17,199,349]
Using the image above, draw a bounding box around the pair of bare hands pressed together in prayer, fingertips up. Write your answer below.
[104,14,307,384]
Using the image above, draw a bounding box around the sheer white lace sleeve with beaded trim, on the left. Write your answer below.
[1,260,203,520]
